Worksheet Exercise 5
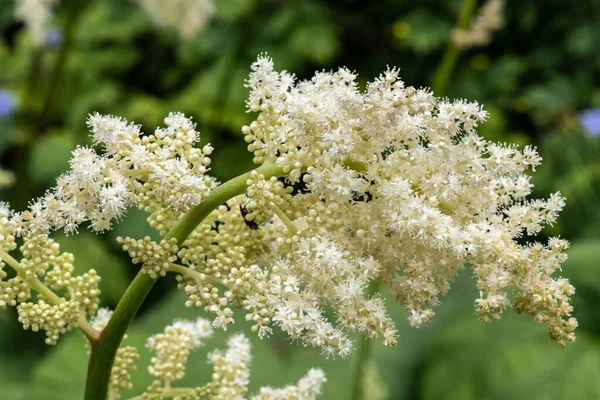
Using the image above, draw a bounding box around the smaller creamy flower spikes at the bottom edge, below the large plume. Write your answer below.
[141,318,326,400]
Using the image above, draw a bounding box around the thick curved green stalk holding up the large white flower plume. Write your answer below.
[85,165,284,400]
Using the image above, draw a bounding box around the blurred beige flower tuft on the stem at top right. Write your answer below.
[452,0,504,49]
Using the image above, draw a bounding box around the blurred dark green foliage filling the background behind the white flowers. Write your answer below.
[0,0,600,400]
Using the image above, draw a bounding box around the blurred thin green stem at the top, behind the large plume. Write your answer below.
[431,0,477,97]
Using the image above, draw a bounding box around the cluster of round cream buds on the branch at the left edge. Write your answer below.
[0,203,100,344]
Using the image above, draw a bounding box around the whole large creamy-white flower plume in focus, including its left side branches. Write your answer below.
[0,56,577,362]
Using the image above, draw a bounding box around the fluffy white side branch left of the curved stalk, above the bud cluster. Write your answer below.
[12,113,214,234]
